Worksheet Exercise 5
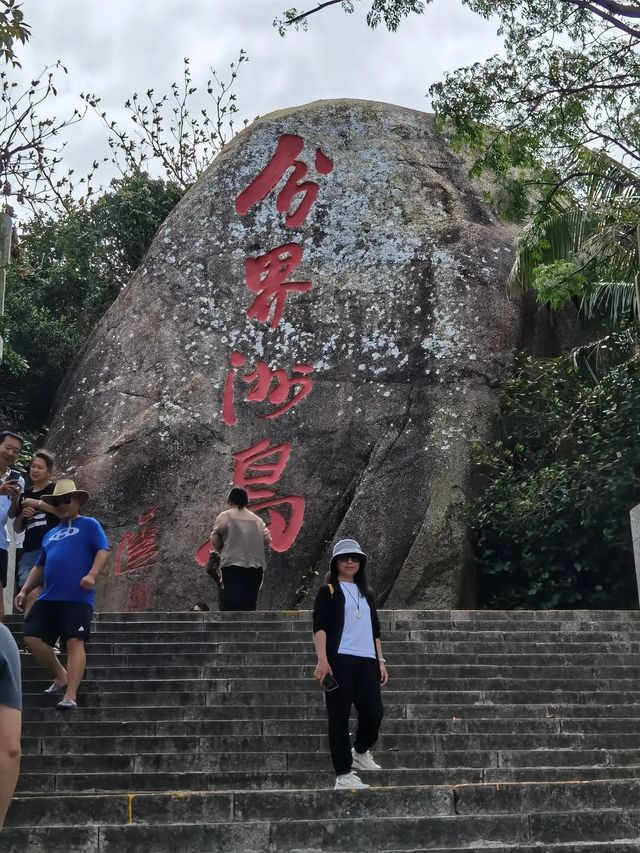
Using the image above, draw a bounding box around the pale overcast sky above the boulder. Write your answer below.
[19,0,500,196]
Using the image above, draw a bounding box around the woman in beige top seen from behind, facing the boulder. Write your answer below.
[211,486,271,610]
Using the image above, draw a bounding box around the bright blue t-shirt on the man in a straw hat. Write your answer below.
[38,515,109,605]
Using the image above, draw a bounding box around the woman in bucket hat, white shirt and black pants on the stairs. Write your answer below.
[313,539,389,789]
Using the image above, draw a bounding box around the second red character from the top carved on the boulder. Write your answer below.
[244,243,311,329]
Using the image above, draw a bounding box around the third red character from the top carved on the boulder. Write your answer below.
[222,350,313,426]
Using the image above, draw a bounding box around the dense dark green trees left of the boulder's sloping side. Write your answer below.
[0,173,182,429]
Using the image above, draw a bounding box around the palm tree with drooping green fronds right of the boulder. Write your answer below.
[508,149,640,375]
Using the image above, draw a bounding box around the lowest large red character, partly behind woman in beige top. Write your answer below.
[233,438,304,552]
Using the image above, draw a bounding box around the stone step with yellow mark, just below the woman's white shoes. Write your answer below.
[7,779,640,827]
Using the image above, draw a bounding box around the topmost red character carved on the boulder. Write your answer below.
[236,133,333,228]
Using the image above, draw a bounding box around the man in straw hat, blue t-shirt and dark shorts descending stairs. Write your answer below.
[16,480,109,710]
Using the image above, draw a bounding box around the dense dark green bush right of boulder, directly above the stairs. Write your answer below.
[468,357,640,609]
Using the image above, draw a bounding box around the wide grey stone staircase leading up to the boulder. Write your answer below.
[0,611,640,853]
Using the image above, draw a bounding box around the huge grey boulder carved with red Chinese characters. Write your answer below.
[50,101,522,609]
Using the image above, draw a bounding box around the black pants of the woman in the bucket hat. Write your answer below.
[326,655,384,776]
